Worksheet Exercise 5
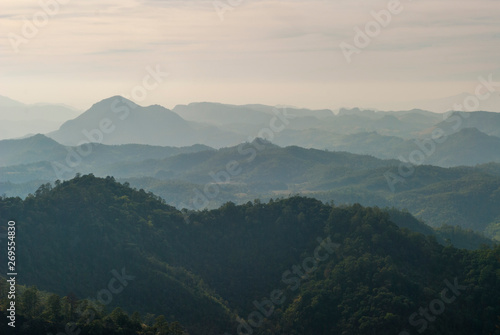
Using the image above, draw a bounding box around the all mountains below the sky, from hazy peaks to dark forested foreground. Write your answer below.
[0,96,500,335]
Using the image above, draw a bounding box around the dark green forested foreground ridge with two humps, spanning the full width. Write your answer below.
[0,175,500,335]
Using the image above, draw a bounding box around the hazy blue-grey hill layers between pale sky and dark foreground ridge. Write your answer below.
[0,96,500,242]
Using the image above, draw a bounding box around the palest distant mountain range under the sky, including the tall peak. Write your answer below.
[42,96,500,167]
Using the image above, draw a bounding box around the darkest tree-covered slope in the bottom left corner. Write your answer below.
[0,284,186,335]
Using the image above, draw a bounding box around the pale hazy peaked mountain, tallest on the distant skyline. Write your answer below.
[47,96,242,150]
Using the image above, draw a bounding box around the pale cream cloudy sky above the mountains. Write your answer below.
[0,0,500,109]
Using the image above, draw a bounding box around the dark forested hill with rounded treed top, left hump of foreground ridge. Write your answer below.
[0,176,232,334]
